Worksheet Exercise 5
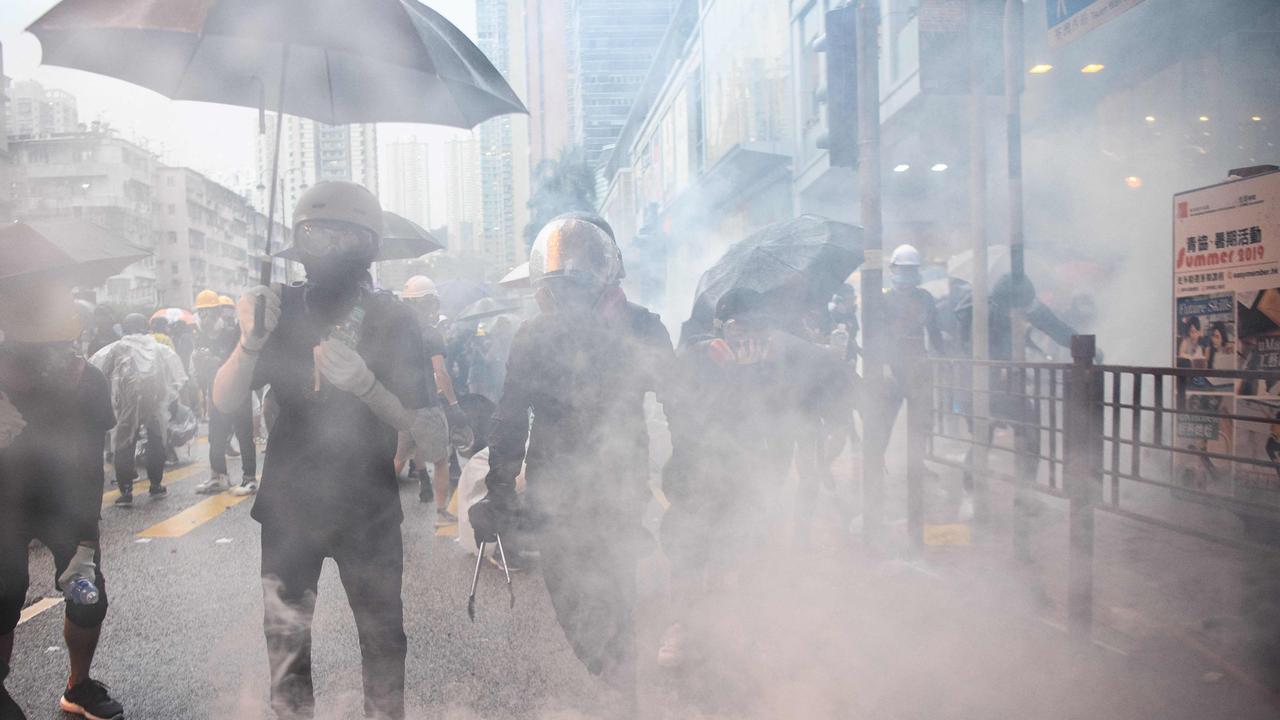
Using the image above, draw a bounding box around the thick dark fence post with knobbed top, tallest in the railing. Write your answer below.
[1062,336,1102,639]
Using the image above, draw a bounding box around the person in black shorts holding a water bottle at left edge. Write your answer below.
[0,277,124,720]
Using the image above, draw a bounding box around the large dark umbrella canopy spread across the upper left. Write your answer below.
[27,0,526,128]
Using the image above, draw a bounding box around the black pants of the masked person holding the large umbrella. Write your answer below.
[262,520,408,720]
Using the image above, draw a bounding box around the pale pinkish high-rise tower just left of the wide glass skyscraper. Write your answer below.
[525,0,573,168]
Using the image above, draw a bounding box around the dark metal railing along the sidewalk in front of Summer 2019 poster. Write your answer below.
[906,336,1280,637]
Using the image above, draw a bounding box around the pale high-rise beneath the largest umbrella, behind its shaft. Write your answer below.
[253,113,378,224]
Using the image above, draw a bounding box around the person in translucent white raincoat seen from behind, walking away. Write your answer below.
[90,313,187,506]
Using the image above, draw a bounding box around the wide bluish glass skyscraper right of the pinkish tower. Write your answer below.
[568,0,676,168]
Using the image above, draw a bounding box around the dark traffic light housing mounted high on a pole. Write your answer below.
[819,3,858,168]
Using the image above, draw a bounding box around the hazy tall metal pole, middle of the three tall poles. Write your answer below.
[968,0,991,523]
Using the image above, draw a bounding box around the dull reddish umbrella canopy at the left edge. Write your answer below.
[0,219,151,287]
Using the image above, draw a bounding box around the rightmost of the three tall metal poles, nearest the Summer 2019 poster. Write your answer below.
[1005,0,1027,363]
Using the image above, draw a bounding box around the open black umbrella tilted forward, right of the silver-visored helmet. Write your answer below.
[685,215,863,336]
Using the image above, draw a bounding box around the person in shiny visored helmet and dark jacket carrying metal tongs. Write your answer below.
[468,215,675,702]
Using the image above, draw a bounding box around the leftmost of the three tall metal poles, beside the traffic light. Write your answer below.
[856,0,890,547]
